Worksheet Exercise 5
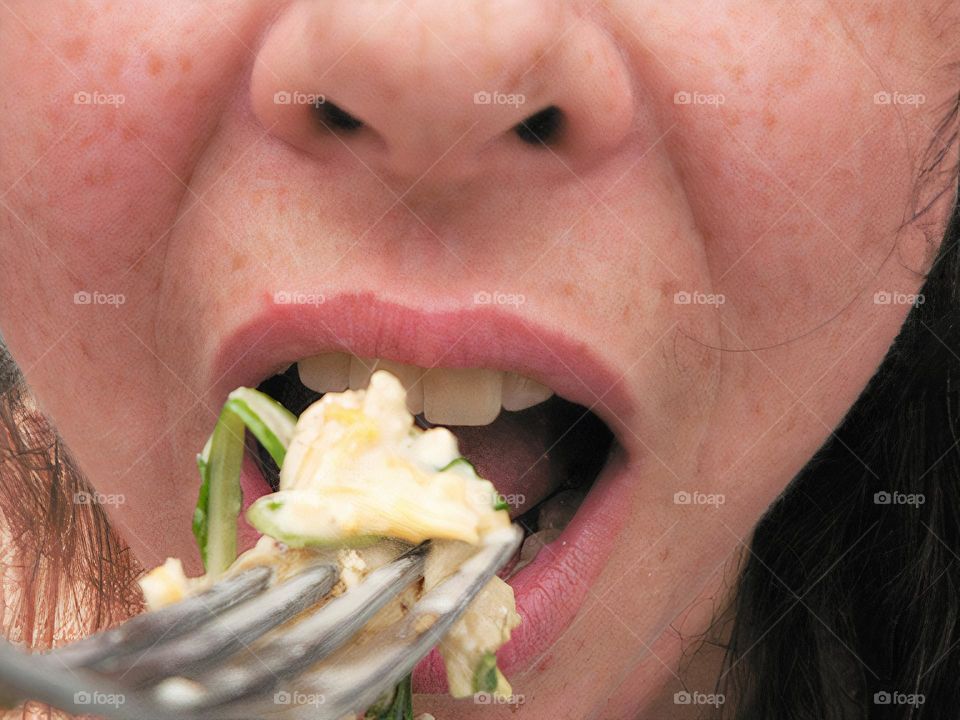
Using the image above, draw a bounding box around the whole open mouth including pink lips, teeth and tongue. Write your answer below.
[211,291,642,693]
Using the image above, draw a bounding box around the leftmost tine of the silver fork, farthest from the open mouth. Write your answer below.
[50,566,273,667]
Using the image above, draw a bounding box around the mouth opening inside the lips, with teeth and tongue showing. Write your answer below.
[251,352,615,579]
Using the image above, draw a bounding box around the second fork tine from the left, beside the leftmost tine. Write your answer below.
[104,563,339,687]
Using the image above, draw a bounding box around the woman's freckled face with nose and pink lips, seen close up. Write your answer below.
[0,0,960,718]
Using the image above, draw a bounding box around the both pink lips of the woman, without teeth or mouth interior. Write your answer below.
[212,294,631,692]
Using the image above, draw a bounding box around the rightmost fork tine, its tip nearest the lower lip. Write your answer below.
[181,526,523,720]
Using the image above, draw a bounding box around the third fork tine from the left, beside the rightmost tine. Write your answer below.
[160,541,430,710]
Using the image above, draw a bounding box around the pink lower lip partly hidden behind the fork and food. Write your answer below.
[238,438,633,693]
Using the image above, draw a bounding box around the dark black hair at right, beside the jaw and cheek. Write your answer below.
[714,91,960,720]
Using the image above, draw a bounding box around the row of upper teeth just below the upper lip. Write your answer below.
[297,352,553,425]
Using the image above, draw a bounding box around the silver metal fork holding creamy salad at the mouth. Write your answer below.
[0,525,523,720]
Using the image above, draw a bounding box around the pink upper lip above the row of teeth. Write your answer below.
[206,292,632,436]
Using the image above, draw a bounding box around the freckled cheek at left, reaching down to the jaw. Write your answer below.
[0,2,267,498]
